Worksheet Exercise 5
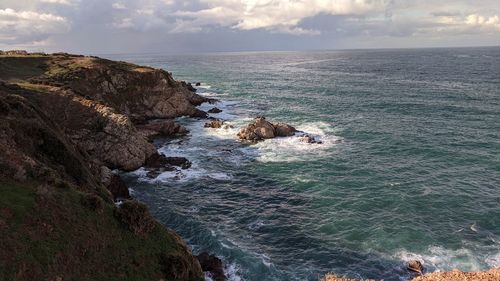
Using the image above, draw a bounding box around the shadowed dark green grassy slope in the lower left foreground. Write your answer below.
[0,180,201,280]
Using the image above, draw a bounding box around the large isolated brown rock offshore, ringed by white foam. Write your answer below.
[238,117,297,141]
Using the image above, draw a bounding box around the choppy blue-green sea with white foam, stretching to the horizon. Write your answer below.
[107,48,500,281]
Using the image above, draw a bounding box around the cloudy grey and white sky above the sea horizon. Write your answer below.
[0,0,500,54]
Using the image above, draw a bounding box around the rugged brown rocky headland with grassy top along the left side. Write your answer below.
[0,55,205,280]
